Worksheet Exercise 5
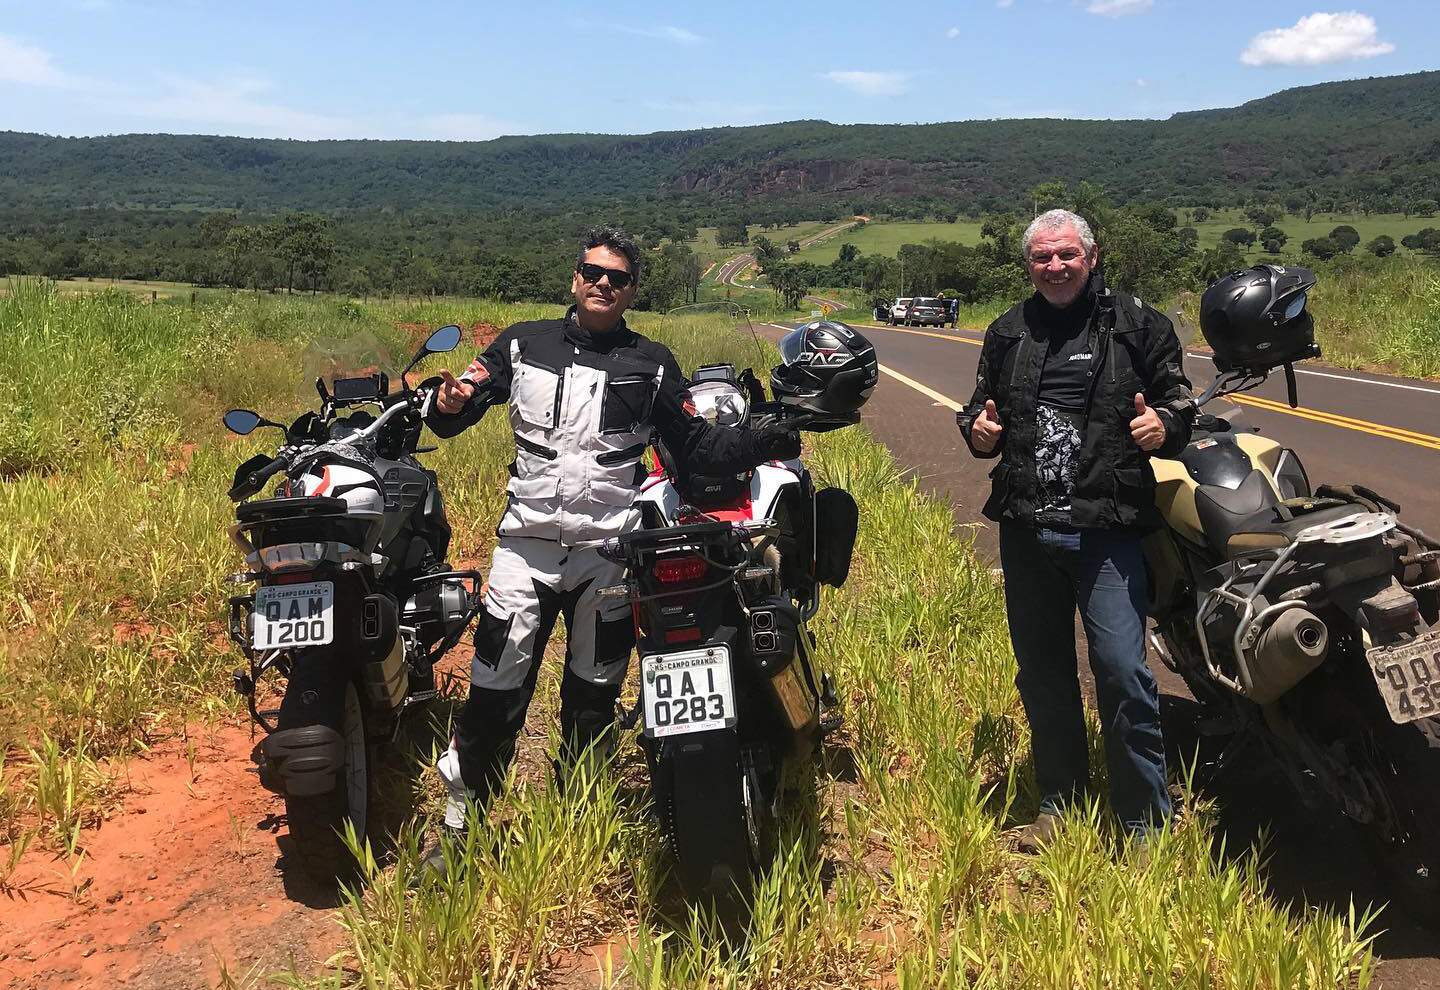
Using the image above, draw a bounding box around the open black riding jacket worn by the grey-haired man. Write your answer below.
[956,278,1195,530]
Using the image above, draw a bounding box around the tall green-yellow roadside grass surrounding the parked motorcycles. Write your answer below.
[0,283,1374,990]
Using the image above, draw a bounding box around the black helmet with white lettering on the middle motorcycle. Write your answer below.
[770,319,880,422]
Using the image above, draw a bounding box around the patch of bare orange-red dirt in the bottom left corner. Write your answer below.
[0,725,341,990]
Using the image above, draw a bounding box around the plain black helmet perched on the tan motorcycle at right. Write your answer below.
[1200,265,1320,371]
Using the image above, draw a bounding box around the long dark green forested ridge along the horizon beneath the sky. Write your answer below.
[0,72,1440,216]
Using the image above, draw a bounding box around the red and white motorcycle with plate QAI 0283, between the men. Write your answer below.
[600,365,858,908]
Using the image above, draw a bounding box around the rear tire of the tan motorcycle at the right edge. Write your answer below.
[1365,711,1440,930]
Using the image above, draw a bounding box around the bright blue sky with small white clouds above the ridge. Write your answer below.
[0,0,1440,140]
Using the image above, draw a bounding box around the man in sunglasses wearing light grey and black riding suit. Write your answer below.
[426,227,801,865]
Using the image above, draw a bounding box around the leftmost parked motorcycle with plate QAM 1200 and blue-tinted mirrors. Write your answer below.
[225,327,482,881]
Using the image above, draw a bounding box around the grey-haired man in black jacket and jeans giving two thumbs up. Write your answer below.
[956,210,1195,852]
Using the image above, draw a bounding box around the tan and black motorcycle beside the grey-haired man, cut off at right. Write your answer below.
[1145,359,1440,919]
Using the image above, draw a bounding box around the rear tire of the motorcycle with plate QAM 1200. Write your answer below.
[285,681,376,884]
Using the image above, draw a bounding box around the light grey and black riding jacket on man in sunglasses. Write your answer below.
[425,308,799,545]
